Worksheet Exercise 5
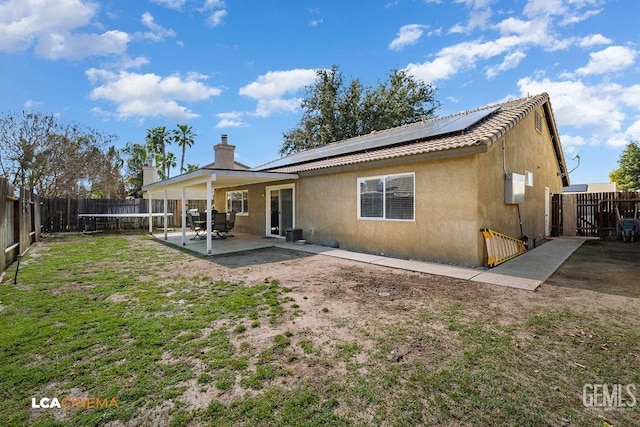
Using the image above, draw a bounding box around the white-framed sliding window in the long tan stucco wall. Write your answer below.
[358,173,415,221]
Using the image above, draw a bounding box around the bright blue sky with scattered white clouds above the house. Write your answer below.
[0,0,640,183]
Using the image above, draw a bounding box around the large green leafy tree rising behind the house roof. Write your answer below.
[280,65,440,155]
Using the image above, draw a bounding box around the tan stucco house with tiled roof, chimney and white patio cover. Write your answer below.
[143,93,569,266]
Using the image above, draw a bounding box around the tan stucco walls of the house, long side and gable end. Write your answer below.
[215,109,562,266]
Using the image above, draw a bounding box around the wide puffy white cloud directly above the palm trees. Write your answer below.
[86,68,221,121]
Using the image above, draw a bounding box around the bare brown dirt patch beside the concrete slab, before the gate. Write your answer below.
[545,240,640,298]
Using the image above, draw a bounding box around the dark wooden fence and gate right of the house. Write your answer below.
[552,192,640,239]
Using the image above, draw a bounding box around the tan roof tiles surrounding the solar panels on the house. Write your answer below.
[253,93,564,173]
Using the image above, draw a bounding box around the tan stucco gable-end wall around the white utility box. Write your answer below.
[478,108,562,263]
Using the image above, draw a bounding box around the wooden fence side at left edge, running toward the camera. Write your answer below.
[0,177,41,274]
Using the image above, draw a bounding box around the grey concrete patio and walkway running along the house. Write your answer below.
[155,233,587,291]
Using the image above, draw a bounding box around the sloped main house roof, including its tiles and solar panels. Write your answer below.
[252,93,569,185]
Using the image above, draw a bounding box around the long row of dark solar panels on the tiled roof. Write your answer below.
[256,107,500,170]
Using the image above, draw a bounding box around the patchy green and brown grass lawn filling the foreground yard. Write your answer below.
[0,235,640,426]
